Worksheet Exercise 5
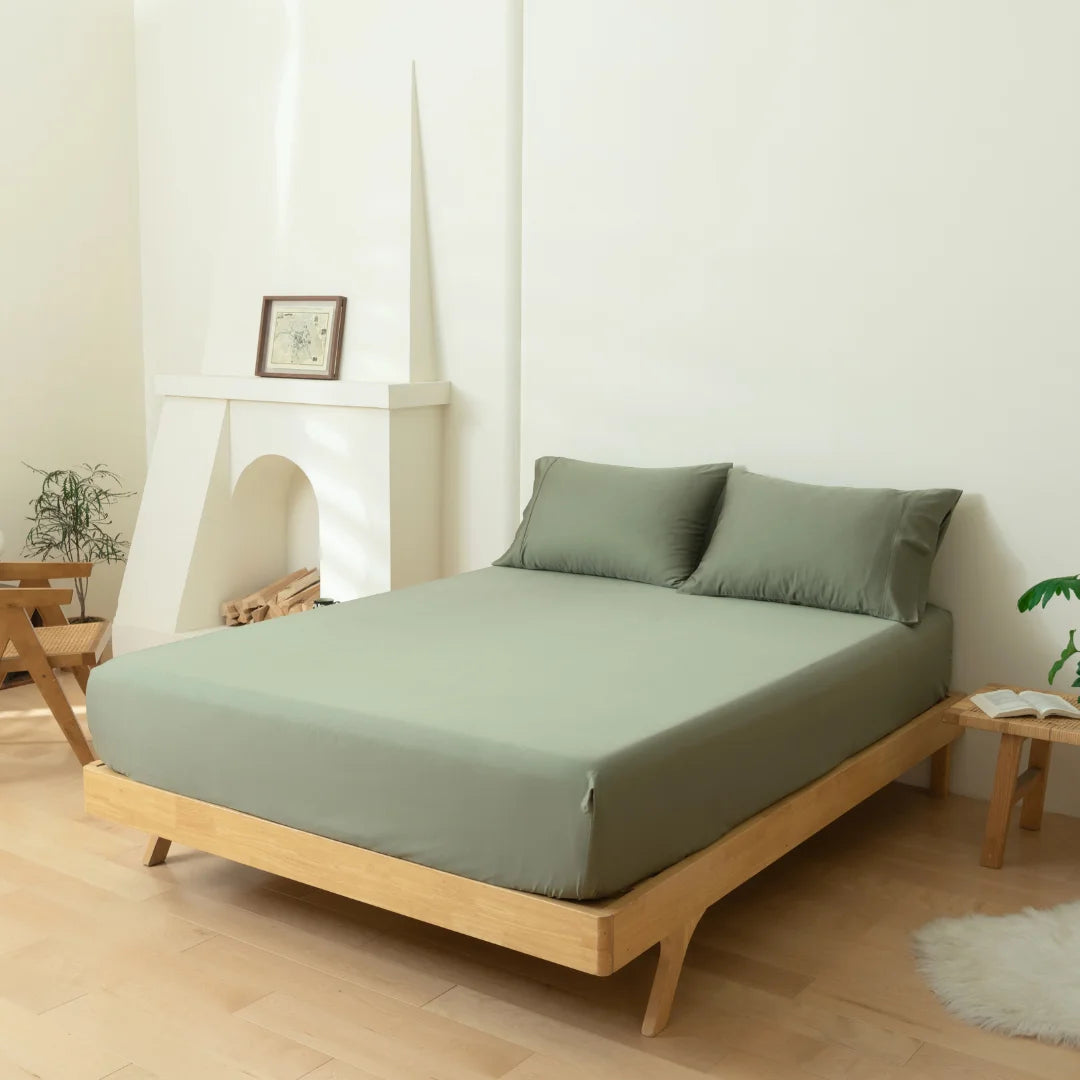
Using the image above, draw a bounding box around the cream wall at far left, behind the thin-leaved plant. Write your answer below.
[0,0,145,616]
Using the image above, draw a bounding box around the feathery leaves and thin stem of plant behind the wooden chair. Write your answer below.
[23,464,135,622]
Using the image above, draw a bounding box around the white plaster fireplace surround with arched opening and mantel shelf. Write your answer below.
[112,375,450,653]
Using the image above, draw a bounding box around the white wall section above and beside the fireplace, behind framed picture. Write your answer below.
[135,0,521,571]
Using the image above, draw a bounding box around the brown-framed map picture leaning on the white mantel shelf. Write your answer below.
[255,296,345,379]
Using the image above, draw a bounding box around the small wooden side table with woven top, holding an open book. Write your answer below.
[945,686,1080,869]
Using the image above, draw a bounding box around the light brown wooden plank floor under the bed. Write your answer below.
[0,685,1080,1080]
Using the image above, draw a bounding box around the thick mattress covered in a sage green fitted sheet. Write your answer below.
[87,567,951,900]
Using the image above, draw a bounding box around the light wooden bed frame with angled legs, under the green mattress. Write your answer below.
[83,698,962,1036]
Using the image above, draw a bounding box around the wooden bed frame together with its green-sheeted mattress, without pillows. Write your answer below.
[85,567,958,1034]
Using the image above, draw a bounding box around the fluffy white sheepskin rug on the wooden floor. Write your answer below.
[913,902,1080,1047]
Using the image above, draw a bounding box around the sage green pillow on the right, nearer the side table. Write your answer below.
[681,469,960,624]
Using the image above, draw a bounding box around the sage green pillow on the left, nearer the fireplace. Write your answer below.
[495,458,731,586]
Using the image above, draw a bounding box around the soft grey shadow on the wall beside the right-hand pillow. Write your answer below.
[932,495,1063,690]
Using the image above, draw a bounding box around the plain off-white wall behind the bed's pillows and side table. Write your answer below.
[522,0,1080,813]
